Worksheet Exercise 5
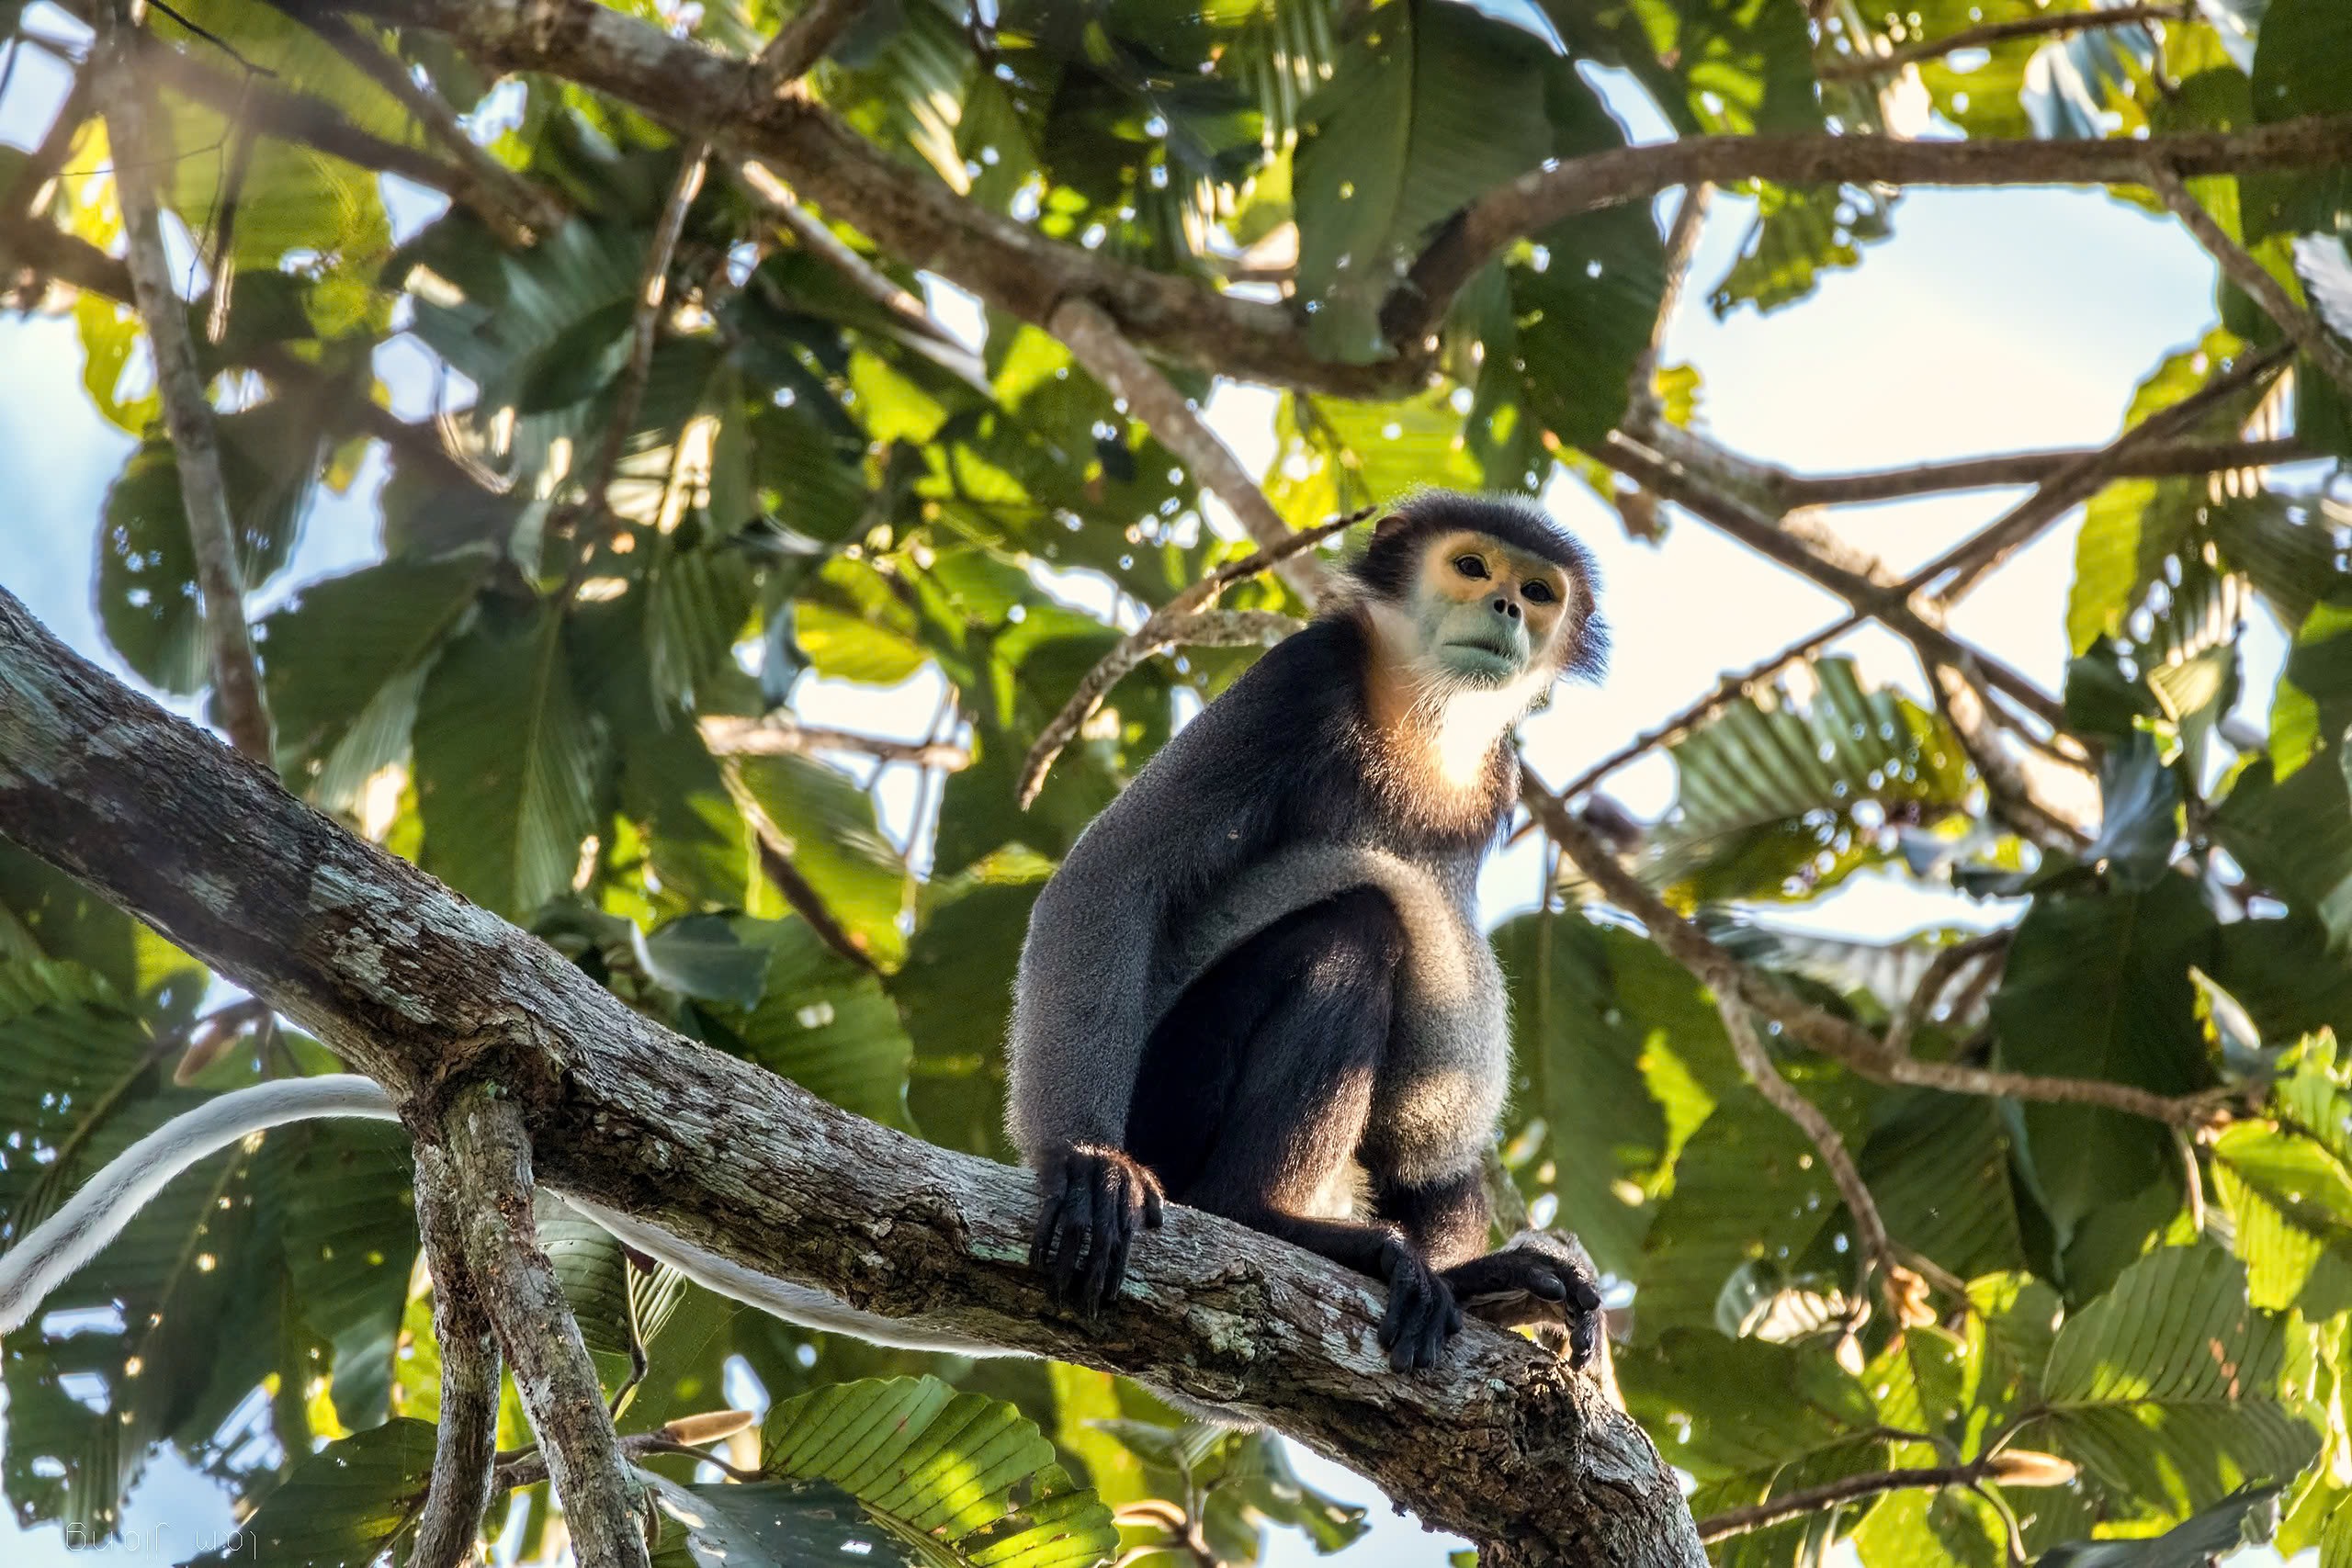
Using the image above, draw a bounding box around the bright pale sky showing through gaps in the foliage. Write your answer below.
[0,7,2314,1568]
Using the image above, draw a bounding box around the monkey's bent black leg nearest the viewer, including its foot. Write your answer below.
[1126,888,1461,1371]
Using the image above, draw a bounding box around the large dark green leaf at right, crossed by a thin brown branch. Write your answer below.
[1992,877,2216,1246]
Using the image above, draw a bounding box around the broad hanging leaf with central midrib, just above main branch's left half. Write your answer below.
[416,609,605,917]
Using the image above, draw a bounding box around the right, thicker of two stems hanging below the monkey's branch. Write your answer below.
[433,1090,651,1568]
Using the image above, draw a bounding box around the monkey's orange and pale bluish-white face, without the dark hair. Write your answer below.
[1408,529,1574,686]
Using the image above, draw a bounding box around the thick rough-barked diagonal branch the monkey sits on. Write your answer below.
[0,592,1705,1568]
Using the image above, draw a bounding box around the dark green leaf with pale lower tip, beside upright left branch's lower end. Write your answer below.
[259,552,489,808]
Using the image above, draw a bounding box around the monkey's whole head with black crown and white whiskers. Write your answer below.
[1350,491,1609,712]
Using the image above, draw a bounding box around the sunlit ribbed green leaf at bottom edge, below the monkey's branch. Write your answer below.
[760,1378,1120,1568]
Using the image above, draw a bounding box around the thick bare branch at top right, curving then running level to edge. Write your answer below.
[1383,115,2352,344]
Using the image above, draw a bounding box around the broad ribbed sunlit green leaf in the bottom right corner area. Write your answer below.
[2025,1246,2319,1512]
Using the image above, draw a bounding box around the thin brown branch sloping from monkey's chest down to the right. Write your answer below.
[1520,778,2221,1126]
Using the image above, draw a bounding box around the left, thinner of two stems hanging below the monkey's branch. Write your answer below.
[409,1142,501,1568]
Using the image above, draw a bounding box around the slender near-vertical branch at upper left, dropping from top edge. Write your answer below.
[89,0,273,764]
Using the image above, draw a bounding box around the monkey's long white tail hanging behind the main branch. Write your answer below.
[0,1075,1007,1357]
